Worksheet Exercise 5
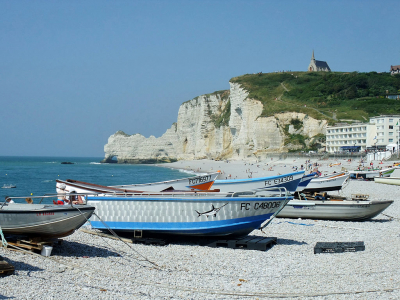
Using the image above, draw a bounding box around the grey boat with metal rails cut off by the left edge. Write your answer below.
[0,196,95,238]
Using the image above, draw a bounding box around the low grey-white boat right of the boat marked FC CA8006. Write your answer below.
[277,196,393,221]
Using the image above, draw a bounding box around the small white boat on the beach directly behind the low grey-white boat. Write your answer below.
[303,172,349,193]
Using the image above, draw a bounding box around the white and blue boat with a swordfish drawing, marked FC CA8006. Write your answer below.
[88,196,293,236]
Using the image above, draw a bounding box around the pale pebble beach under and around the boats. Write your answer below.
[0,158,400,299]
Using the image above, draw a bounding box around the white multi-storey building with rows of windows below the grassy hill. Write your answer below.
[326,115,400,152]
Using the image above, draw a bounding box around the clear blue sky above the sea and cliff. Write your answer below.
[0,0,400,157]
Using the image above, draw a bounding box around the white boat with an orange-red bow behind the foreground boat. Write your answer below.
[112,172,220,192]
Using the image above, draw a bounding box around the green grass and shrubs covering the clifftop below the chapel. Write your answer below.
[230,72,400,124]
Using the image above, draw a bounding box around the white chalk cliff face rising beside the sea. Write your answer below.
[103,83,327,163]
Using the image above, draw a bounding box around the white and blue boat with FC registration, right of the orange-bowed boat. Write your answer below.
[213,171,304,193]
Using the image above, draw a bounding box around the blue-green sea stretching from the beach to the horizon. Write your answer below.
[0,156,195,203]
